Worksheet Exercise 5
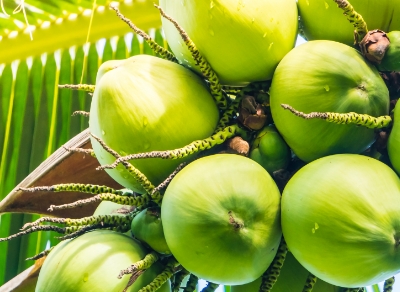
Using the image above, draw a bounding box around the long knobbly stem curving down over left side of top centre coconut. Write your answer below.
[154,4,228,110]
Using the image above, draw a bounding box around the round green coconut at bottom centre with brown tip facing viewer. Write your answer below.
[161,154,281,285]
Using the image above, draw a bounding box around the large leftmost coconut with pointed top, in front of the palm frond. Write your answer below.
[89,55,219,193]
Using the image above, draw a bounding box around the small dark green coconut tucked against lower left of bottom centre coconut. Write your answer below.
[131,208,171,254]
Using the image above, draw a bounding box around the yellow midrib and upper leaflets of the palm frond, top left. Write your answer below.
[0,0,161,64]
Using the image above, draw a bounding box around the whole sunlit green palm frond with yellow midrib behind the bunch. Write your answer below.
[0,0,163,290]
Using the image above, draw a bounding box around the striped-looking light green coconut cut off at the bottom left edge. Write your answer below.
[35,230,171,292]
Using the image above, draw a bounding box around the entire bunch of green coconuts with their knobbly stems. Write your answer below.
[1,0,400,292]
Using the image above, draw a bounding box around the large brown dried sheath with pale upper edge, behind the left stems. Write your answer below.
[0,130,123,218]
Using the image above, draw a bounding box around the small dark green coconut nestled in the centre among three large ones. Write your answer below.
[249,125,291,175]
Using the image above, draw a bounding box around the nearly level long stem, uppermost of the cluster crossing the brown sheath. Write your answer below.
[19,183,124,195]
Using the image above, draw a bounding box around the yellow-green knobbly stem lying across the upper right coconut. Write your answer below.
[281,104,392,129]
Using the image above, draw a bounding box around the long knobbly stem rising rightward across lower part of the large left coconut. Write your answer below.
[99,125,246,169]
